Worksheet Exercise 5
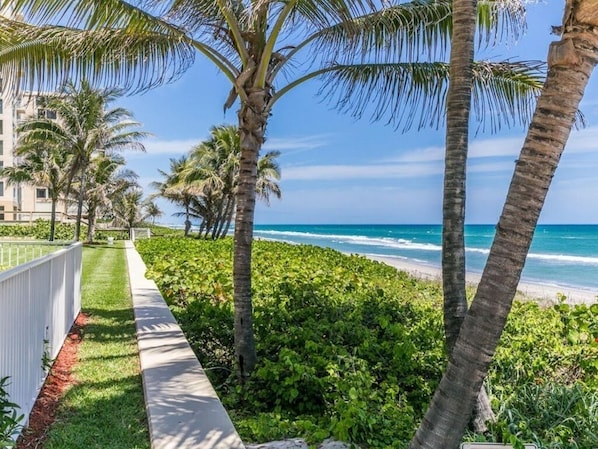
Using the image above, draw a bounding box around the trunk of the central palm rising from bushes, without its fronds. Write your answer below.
[233,90,268,379]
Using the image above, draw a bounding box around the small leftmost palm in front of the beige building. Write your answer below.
[0,130,69,241]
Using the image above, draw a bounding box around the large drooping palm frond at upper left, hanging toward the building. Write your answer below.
[0,19,196,92]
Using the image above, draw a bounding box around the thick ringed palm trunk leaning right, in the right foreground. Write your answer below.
[410,10,598,449]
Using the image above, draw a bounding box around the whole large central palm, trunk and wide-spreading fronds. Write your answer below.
[0,0,544,378]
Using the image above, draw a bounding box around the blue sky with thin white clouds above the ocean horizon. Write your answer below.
[120,0,598,224]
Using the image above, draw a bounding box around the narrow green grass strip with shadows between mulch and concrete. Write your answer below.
[44,242,150,449]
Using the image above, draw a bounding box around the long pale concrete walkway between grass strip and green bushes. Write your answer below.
[125,241,245,449]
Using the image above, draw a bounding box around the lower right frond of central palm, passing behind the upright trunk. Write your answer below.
[320,62,543,131]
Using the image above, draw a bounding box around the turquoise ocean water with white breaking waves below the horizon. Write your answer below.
[255,225,598,291]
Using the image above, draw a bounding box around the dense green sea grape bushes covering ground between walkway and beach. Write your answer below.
[136,238,598,448]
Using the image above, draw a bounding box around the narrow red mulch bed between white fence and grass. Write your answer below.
[16,313,89,449]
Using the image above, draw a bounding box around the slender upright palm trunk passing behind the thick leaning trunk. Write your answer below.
[442,0,495,432]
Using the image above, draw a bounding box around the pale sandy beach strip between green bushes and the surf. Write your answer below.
[367,255,598,304]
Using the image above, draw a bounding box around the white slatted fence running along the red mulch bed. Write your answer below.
[0,243,82,430]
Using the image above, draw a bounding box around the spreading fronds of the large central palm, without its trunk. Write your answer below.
[0,0,542,129]
